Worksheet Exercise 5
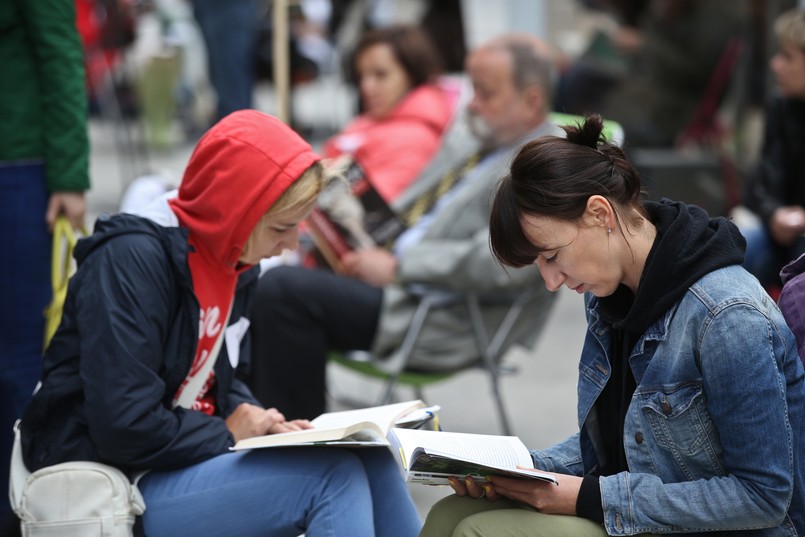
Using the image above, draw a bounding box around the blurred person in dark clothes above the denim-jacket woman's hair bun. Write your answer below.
[555,0,748,147]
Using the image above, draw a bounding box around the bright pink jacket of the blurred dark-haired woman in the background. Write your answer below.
[323,85,455,202]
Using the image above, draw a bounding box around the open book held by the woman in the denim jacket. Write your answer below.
[388,428,557,485]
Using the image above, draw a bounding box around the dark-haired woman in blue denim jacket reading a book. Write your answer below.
[421,116,805,536]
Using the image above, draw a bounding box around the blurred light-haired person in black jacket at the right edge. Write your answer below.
[739,7,805,294]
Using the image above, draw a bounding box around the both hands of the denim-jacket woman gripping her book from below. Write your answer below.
[450,472,582,516]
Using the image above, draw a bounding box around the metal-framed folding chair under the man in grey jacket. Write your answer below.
[330,282,540,435]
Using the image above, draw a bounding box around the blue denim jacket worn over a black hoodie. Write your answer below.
[532,266,805,536]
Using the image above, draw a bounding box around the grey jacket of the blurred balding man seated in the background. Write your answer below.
[372,118,564,370]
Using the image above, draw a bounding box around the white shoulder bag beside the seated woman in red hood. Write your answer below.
[9,422,145,537]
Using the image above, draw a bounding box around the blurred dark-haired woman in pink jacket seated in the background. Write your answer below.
[324,25,457,203]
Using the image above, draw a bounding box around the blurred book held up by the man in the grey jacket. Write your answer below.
[307,161,405,272]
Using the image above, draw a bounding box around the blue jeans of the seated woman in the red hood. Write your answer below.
[140,447,421,537]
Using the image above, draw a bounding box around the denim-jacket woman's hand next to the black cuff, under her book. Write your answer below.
[487,472,582,516]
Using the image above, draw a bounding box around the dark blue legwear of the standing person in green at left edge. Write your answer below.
[0,163,51,524]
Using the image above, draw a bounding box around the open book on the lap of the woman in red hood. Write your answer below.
[232,400,435,450]
